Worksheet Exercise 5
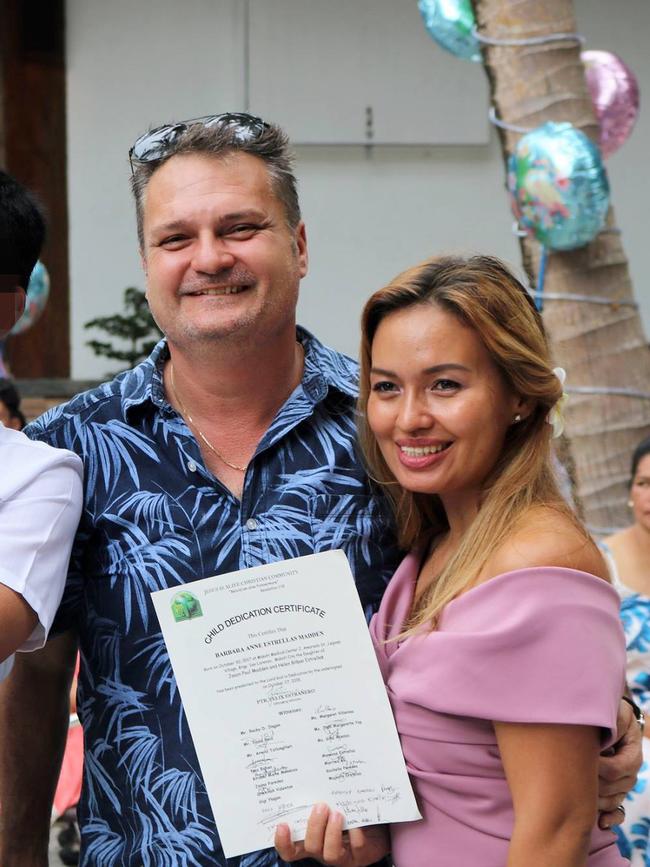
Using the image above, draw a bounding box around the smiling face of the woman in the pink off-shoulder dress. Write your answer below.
[367,304,526,506]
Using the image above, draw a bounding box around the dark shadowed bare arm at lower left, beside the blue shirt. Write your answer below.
[0,632,77,867]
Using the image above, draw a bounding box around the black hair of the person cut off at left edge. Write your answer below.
[0,170,45,291]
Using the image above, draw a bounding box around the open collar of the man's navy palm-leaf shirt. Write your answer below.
[120,325,359,418]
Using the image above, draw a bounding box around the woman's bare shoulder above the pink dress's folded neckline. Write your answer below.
[481,506,609,581]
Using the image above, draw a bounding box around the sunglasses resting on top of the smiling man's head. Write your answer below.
[129,111,269,173]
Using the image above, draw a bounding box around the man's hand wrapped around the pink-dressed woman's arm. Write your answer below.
[598,701,643,828]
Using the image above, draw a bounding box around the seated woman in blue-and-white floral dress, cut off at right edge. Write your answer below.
[602,437,650,867]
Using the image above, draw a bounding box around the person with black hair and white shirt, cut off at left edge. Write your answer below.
[0,171,82,681]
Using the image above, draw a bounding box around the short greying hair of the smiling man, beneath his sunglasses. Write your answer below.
[131,121,300,249]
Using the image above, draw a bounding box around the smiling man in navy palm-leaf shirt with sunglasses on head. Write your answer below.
[0,114,636,867]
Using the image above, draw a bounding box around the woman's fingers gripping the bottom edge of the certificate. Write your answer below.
[275,804,390,867]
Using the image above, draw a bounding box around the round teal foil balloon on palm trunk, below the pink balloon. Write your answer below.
[508,122,609,250]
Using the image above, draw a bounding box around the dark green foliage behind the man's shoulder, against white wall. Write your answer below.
[84,286,162,375]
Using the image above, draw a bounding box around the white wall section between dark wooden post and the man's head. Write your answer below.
[66,0,243,379]
